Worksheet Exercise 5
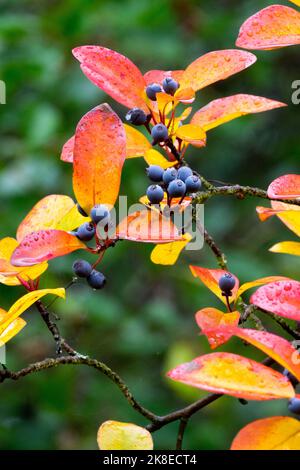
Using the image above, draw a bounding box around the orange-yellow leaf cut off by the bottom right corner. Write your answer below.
[231,416,300,450]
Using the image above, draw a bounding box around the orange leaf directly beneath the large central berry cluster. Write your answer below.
[115,210,184,243]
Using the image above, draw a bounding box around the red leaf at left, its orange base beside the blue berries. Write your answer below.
[11,230,86,266]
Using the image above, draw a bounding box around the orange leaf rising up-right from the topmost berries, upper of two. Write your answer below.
[180,49,256,91]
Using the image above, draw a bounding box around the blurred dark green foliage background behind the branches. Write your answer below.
[0,0,300,449]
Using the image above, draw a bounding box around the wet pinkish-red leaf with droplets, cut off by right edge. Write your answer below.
[250,281,300,321]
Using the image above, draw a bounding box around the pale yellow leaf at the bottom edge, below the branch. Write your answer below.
[97,421,153,450]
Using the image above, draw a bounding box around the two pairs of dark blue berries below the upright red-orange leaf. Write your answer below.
[73,204,110,289]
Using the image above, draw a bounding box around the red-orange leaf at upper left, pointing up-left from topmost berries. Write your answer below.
[73,46,147,111]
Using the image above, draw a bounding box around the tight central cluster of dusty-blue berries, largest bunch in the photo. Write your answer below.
[146,165,201,204]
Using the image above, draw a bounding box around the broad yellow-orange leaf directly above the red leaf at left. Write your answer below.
[17,194,89,242]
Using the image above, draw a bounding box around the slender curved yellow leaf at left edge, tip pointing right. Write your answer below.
[0,287,65,334]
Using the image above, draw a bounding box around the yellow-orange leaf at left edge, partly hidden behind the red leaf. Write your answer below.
[0,237,48,286]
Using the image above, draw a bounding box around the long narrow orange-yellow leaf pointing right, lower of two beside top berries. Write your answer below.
[191,94,286,131]
